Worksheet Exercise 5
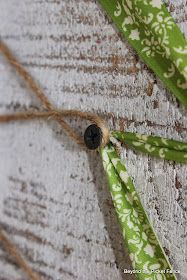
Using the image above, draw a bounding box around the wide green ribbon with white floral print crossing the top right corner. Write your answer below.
[99,0,187,107]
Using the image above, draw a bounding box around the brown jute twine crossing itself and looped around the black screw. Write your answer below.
[0,40,109,150]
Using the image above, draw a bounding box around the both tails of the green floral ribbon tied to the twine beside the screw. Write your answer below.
[100,131,187,280]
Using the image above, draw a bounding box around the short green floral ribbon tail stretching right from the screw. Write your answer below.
[111,131,187,163]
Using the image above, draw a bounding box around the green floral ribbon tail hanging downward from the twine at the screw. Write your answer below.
[101,143,176,280]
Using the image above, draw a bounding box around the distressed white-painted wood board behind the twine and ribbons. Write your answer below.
[0,0,187,280]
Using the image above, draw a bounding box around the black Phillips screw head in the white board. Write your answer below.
[84,124,103,150]
